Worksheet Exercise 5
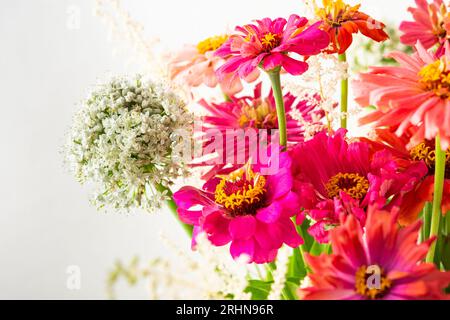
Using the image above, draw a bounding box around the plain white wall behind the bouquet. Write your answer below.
[0,0,413,299]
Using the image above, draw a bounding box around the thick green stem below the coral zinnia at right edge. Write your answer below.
[426,135,446,263]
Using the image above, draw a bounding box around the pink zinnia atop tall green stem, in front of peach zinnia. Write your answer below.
[216,15,330,79]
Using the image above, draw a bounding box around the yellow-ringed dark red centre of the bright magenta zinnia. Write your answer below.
[214,165,267,217]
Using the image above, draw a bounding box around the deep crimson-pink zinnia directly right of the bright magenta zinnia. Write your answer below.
[291,129,425,243]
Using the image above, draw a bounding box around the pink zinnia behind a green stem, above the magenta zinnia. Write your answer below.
[194,83,324,180]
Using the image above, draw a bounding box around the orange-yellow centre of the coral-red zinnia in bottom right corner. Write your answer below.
[355,265,392,300]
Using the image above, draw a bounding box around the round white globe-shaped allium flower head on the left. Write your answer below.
[65,76,193,211]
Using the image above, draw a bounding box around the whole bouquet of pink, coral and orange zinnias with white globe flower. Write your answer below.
[66,0,450,300]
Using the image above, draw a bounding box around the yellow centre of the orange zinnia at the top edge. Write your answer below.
[314,0,361,27]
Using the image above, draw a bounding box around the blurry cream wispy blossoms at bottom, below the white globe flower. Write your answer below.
[108,235,251,300]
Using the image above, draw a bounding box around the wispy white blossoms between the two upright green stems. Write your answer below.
[285,54,348,132]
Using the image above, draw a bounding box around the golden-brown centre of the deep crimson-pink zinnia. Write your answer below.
[325,173,369,200]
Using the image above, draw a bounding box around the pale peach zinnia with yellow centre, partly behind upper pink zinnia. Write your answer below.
[169,35,259,95]
